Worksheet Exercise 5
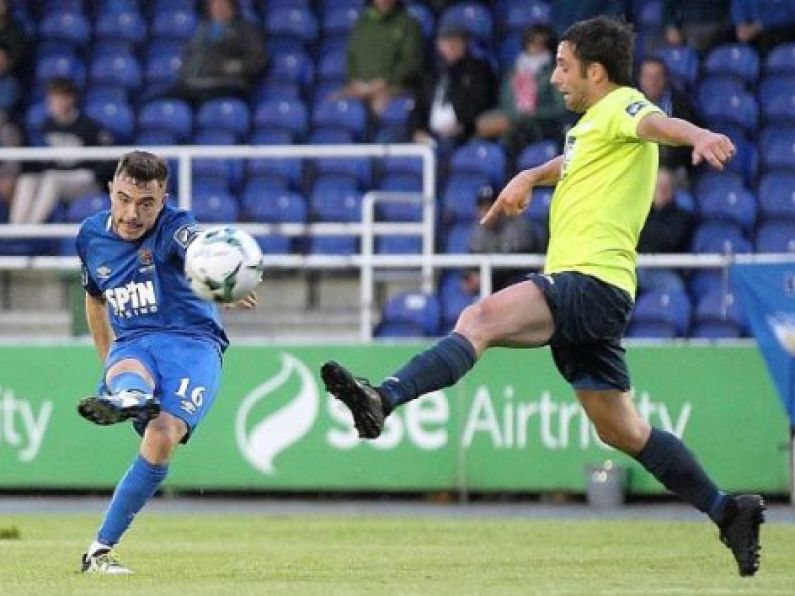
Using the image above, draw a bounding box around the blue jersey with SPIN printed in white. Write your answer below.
[77,205,229,351]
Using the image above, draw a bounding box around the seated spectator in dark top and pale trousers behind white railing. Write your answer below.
[10,79,114,223]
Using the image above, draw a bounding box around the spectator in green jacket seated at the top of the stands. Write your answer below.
[342,0,424,114]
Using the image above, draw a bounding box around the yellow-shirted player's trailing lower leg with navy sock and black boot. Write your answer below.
[577,389,764,575]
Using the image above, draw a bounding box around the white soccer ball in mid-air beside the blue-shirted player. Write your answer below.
[185,226,263,303]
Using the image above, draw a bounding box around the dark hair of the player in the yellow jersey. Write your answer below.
[561,17,634,85]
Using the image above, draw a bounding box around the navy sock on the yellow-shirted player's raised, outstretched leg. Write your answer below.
[379,333,477,411]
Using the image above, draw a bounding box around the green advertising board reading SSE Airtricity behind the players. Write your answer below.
[0,344,789,494]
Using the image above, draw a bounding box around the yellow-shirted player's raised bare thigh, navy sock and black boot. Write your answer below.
[321,281,554,438]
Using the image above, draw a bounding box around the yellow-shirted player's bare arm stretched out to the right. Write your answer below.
[638,113,737,170]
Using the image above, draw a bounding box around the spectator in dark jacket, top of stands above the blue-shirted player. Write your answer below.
[172,0,267,105]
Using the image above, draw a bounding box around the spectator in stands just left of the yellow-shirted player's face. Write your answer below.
[477,25,566,155]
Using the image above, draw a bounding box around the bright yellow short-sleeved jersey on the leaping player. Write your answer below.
[544,87,662,296]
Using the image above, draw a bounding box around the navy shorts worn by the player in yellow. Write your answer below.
[527,271,633,391]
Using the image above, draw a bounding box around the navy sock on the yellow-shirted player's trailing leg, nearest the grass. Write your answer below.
[635,428,731,524]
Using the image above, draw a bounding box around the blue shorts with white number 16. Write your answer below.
[103,333,222,443]
